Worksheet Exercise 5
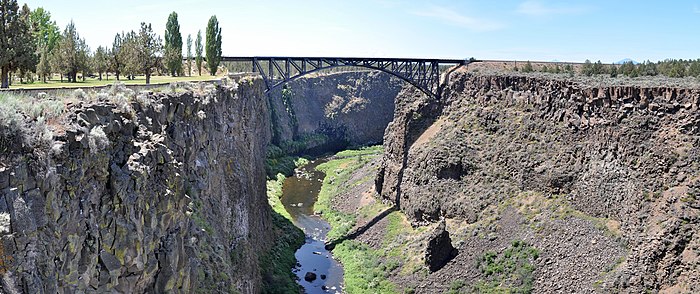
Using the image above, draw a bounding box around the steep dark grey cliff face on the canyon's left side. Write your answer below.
[0,79,272,293]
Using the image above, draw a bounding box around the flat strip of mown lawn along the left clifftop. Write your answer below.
[10,75,220,89]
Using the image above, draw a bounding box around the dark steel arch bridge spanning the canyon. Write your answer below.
[221,57,474,98]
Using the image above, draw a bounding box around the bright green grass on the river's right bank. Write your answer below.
[314,146,432,293]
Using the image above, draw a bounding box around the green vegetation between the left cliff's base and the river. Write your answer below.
[260,169,304,294]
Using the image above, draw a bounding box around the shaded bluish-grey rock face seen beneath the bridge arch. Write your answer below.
[270,72,404,153]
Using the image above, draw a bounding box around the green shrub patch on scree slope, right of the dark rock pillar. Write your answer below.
[470,240,539,293]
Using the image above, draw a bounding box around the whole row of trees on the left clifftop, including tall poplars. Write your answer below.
[0,0,222,88]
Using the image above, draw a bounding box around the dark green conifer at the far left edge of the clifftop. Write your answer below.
[0,0,36,88]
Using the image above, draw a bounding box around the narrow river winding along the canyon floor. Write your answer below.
[281,159,343,294]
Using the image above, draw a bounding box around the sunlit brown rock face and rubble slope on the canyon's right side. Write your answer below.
[376,71,700,292]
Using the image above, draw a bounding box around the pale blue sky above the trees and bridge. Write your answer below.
[24,0,700,62]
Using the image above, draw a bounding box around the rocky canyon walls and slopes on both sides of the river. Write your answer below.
[0,67,700,293]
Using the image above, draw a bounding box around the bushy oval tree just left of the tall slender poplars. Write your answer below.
[136,22,163,85]
